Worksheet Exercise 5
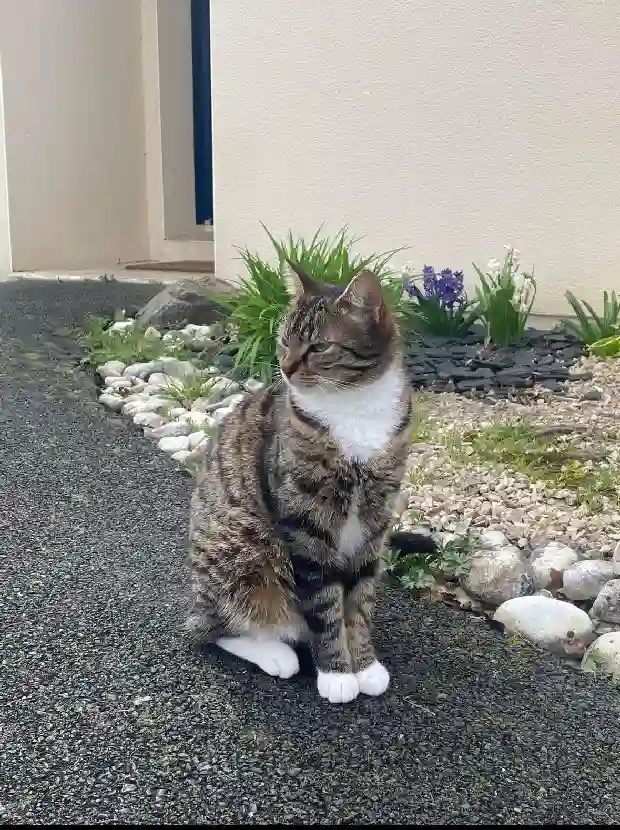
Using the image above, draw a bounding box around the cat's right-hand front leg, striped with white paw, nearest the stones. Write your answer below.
[345,551,390,697]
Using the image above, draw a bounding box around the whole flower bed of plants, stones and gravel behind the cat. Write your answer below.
[82,231,620,677]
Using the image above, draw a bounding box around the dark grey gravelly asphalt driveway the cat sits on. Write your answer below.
[0,282,620,825]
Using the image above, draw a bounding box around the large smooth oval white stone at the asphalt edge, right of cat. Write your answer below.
[493,595,594,655]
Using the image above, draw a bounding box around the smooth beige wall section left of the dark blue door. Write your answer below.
[0,0,148,270]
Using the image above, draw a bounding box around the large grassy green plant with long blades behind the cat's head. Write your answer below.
[218,226,403,383]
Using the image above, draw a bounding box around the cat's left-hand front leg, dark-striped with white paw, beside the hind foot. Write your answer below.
[293,552,359,703]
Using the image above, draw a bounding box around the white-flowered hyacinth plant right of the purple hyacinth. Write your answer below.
[473,248,536,346]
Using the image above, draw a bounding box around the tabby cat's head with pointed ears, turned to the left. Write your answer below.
[278,263,398,391]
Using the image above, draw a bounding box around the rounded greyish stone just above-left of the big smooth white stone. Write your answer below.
[461,545,532,605]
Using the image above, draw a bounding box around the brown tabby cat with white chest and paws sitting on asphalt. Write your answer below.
[186,263,433,703]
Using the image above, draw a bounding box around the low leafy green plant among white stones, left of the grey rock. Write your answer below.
[77,317,172,366]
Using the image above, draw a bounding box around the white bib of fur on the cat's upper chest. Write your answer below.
[291,366,405,461]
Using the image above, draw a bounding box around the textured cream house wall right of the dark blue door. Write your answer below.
[211,0,620,313]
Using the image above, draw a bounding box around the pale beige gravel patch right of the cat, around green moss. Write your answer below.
[407,368,620,559]
